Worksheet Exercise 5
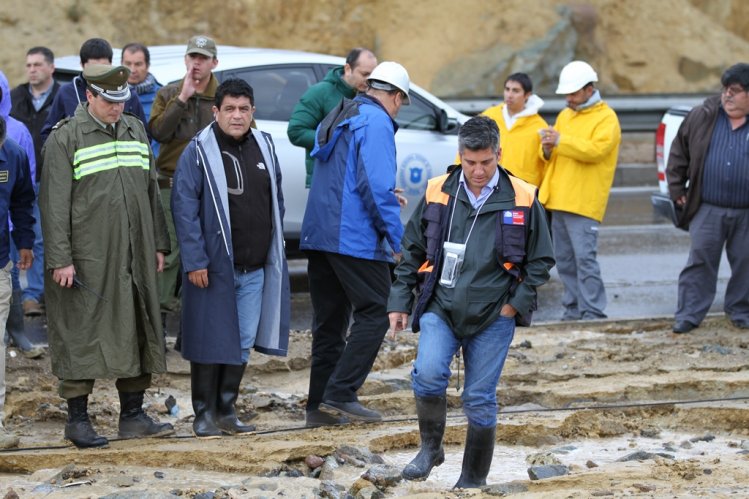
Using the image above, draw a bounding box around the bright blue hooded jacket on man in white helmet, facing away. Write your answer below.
[299,95,403,262]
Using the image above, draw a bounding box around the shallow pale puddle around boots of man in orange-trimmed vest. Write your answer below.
[384,432,739,490]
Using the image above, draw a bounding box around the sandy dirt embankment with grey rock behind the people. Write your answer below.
[0,0,749,96]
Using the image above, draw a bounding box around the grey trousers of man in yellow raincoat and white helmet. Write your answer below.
[551,211,606,320]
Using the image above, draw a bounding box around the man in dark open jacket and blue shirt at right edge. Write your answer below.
[666,63,749,333]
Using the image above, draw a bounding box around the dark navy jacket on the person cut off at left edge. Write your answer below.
[0,138,34,268]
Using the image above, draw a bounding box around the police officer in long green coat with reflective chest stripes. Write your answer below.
[39,65,174,447]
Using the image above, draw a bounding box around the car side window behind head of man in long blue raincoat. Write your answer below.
[224,66,317,121]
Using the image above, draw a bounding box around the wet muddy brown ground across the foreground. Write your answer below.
[0,316,749,499]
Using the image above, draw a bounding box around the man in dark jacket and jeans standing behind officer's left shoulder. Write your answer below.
[10,47,60,316]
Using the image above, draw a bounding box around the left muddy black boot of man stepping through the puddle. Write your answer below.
[401,396,447,480]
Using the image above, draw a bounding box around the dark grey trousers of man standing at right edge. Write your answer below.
[676,203,749,324]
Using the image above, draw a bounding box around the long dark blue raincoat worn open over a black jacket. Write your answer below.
[171,125,291,364]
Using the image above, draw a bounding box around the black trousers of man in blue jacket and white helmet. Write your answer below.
[307,251,391,411]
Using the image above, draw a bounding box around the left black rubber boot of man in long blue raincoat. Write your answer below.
[190,362,221,438]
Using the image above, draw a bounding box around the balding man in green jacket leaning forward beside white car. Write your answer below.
[286,48,377,188]
